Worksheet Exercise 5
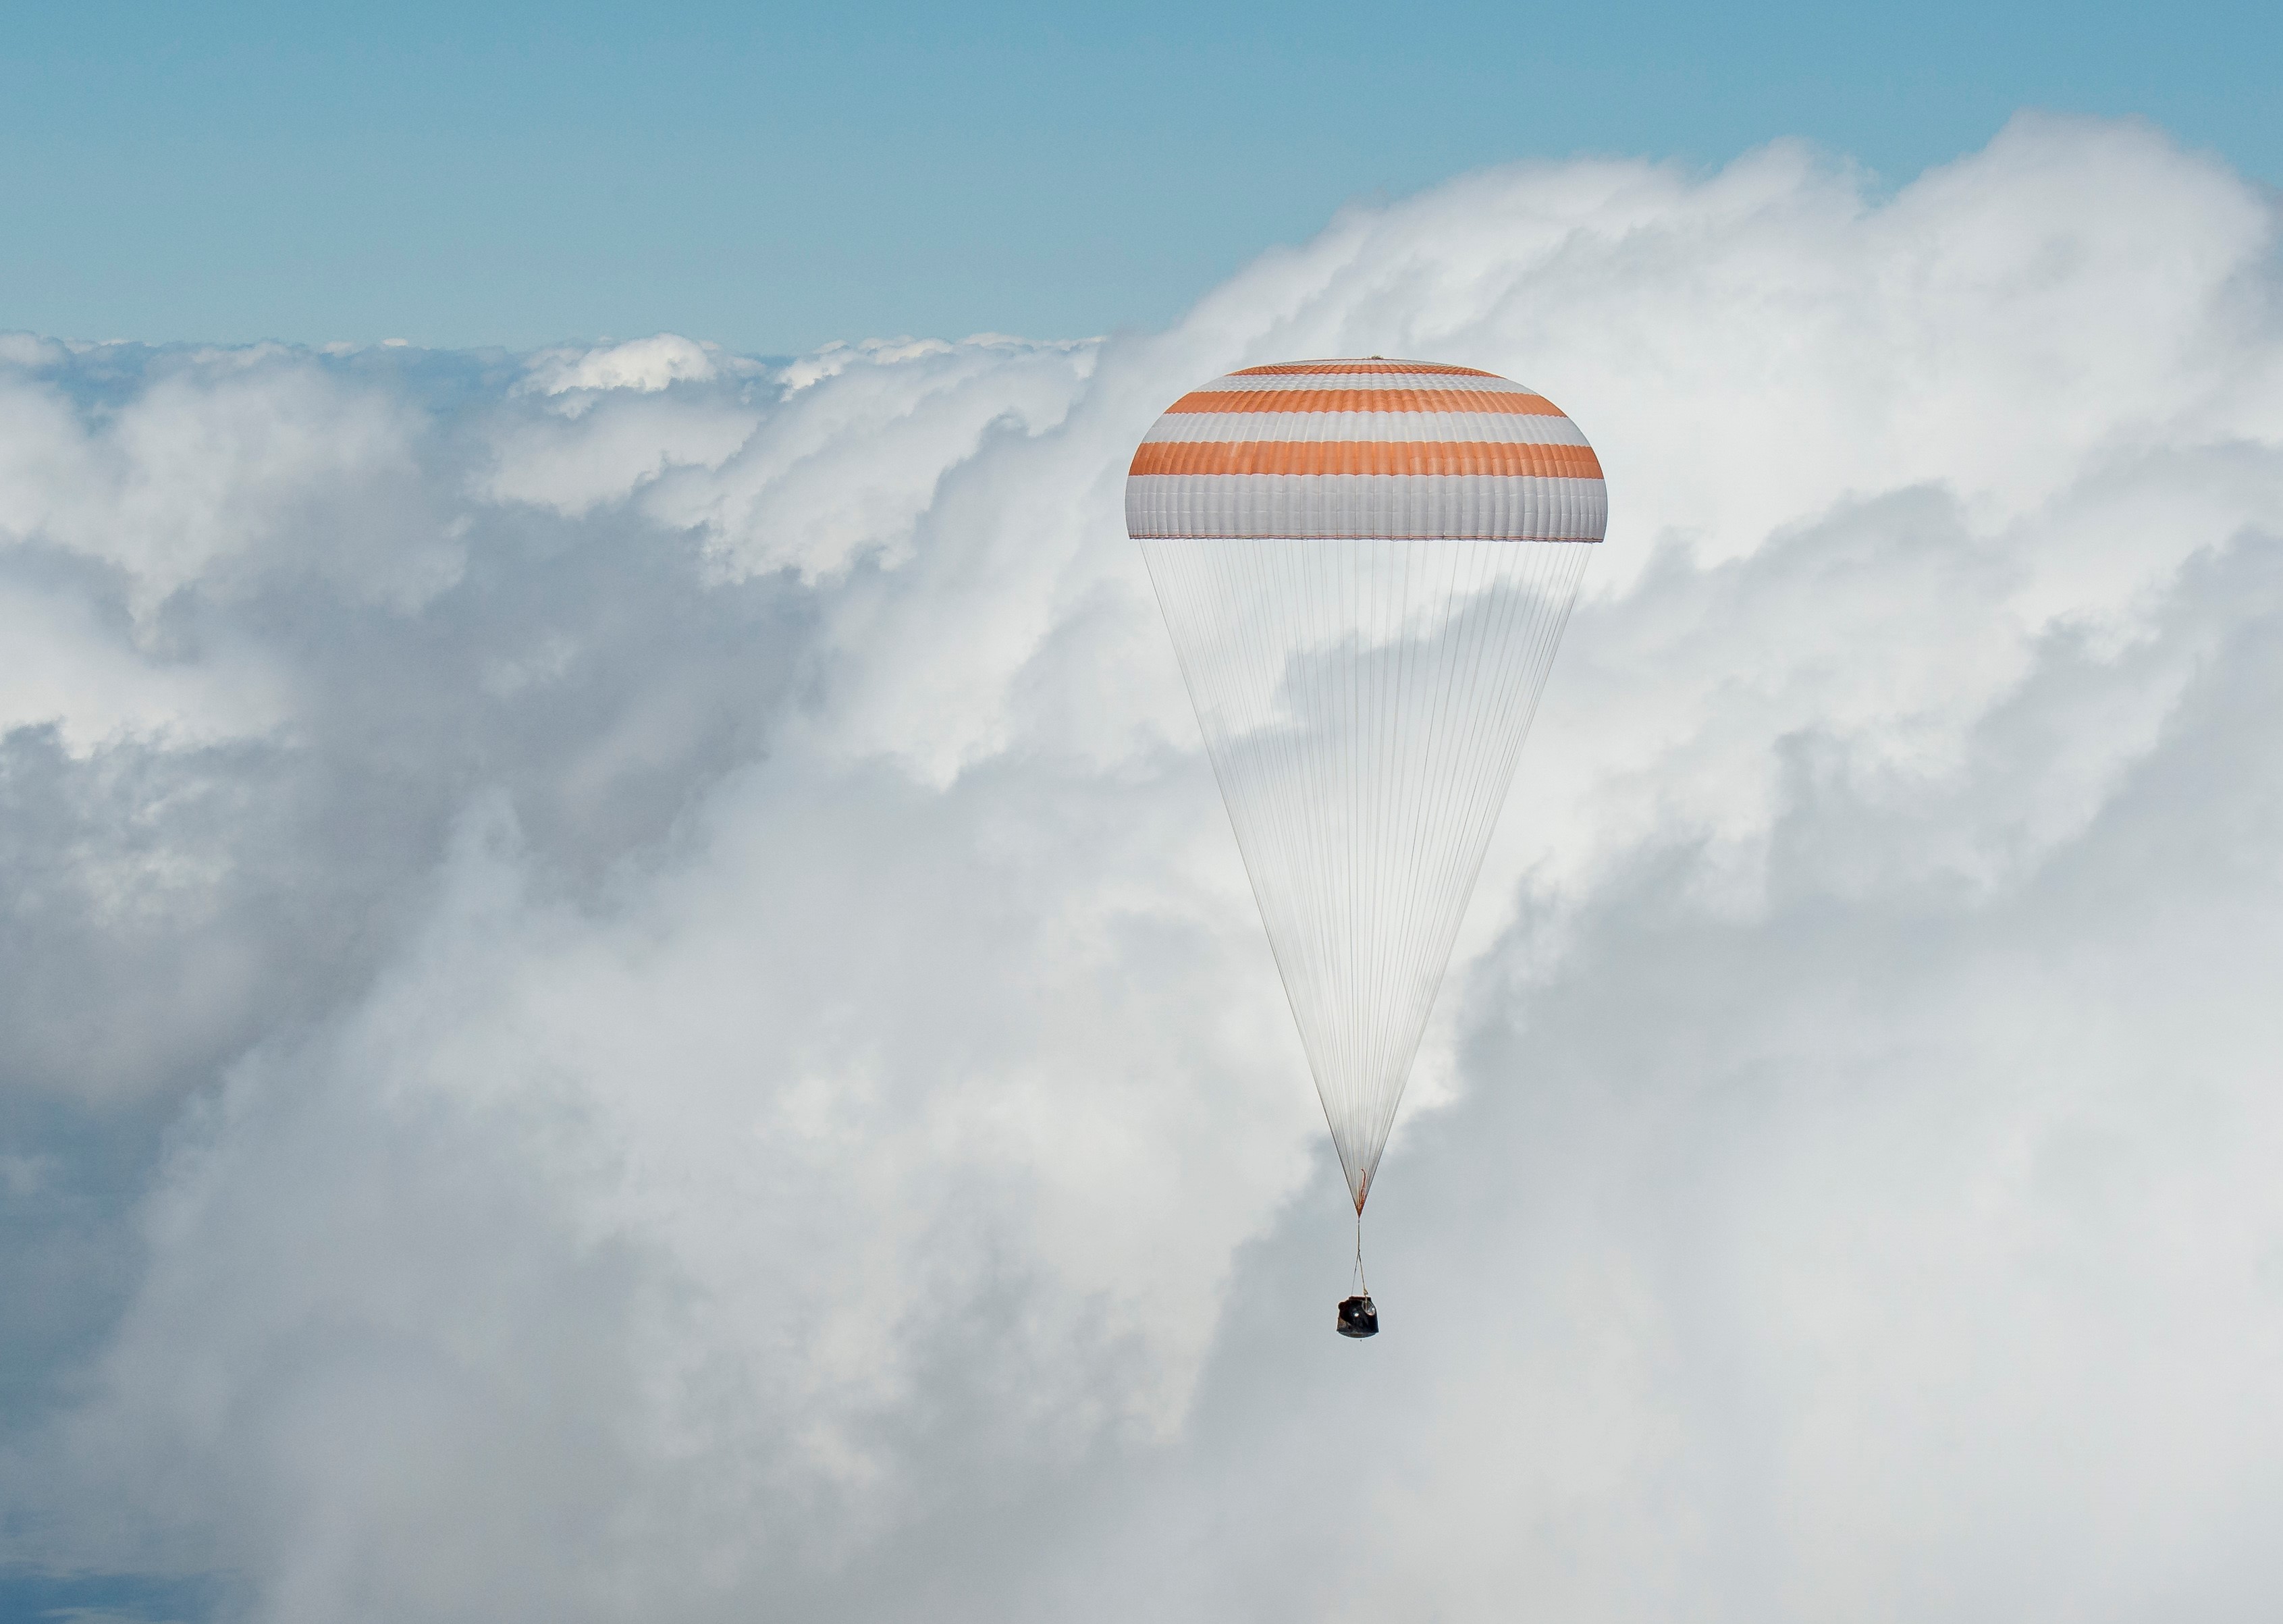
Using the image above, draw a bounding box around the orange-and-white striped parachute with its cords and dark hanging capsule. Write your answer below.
[1125,356,1607,1336]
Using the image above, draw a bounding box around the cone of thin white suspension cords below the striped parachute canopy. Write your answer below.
[1139,534,1601,1213]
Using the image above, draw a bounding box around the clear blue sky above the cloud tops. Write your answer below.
[0,2,2283,352]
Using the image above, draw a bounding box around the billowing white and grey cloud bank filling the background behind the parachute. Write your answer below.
[0,107,2283,1622]
